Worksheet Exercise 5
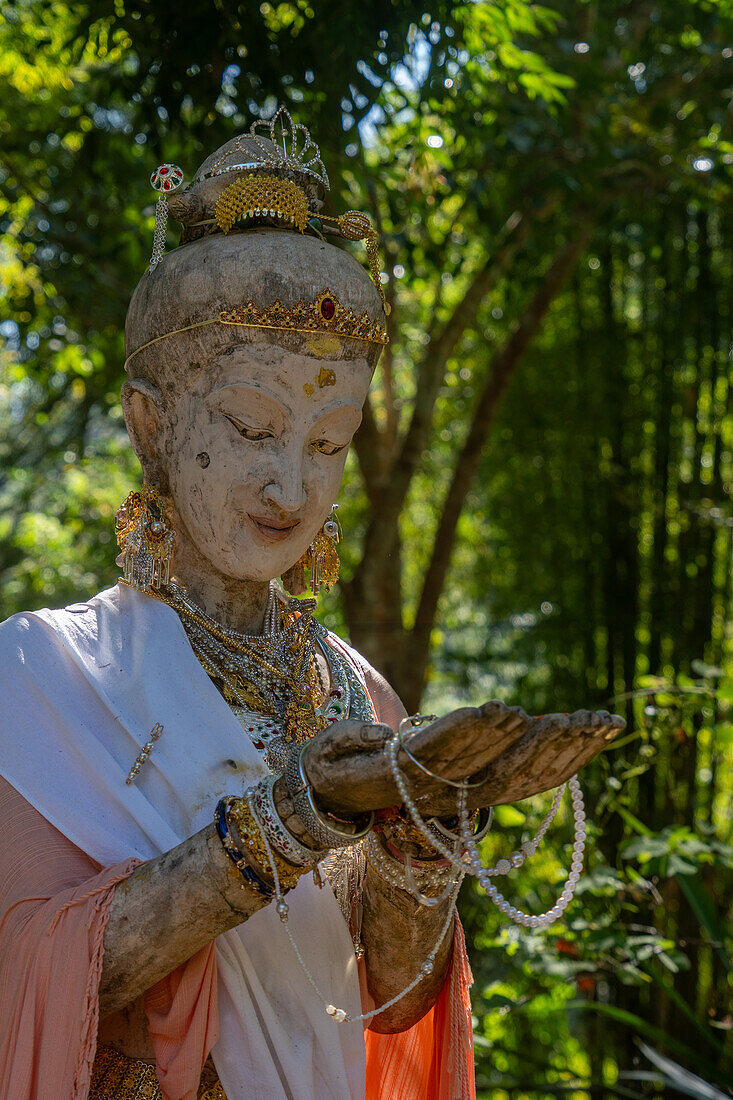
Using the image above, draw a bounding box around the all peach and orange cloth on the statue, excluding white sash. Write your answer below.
[0,663,475,1100]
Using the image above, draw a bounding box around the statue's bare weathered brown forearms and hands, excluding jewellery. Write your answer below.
[100,702,624,1016]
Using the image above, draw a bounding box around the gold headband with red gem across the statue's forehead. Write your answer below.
[124,287,390,371]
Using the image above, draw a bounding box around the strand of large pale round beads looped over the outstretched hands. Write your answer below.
[387,734,586,928]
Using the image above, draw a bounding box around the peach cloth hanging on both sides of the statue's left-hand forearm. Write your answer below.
[0,778,219,1100]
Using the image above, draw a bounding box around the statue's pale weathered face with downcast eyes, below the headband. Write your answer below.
[168,342,371,581]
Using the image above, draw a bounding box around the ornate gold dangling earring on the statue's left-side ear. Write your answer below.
[114,485,175,589]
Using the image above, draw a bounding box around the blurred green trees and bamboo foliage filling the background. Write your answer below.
[0,0,733,1100]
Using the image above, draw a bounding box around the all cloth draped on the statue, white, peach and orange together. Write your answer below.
[0,589,470,1100]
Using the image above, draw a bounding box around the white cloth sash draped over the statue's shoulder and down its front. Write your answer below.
[0,586,365,1100]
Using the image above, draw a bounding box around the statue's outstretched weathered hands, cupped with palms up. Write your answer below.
[304,701,625,815]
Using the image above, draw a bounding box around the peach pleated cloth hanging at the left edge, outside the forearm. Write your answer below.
[0,779,139,1100]
